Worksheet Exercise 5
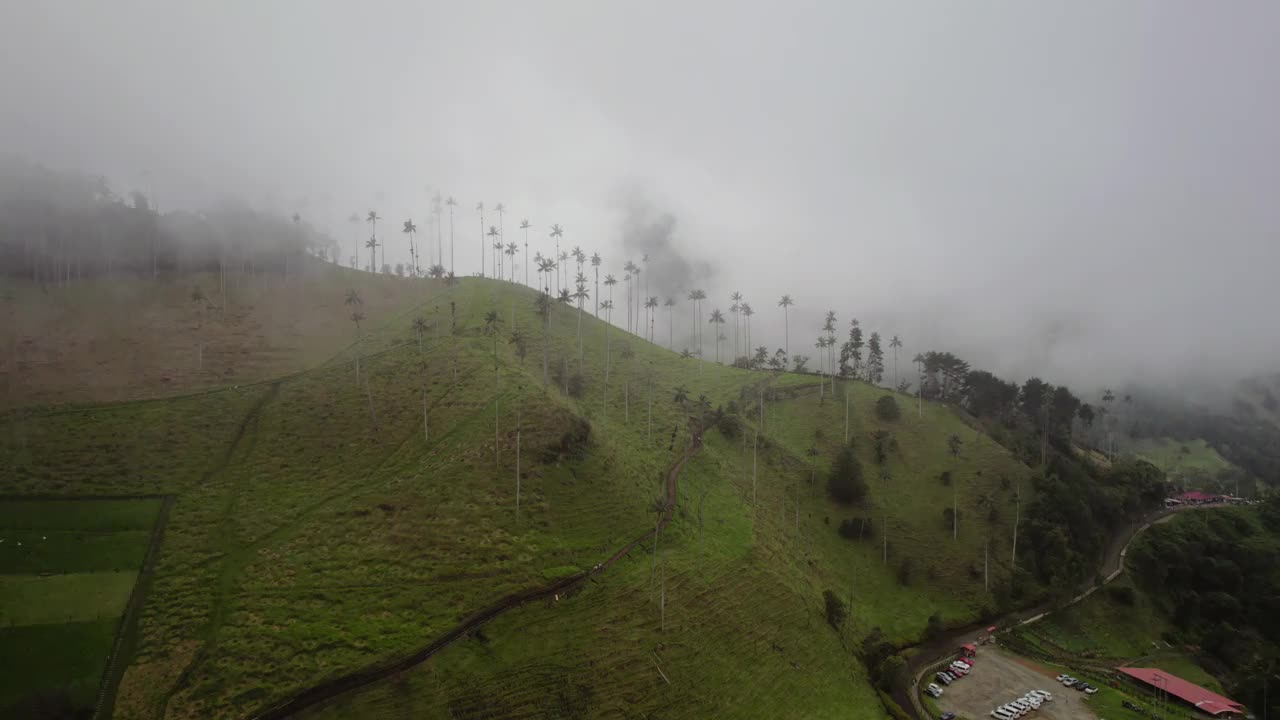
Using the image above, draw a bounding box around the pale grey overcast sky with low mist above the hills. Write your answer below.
[0,0,1280,392]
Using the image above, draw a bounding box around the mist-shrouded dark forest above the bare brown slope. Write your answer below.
[0,156,335,284]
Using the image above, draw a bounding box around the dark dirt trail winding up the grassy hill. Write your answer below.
[251,418,703,720]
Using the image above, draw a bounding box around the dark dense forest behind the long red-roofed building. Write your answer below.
[1129,497,1280,717]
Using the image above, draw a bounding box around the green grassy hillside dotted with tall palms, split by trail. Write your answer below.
[0,271,1028,717]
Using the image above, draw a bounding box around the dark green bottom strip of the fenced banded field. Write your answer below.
[0,619,115,717]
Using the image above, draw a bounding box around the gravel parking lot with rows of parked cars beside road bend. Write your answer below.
[923,646,1097,720]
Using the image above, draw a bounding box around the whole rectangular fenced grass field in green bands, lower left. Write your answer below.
[0,500,160,717]
